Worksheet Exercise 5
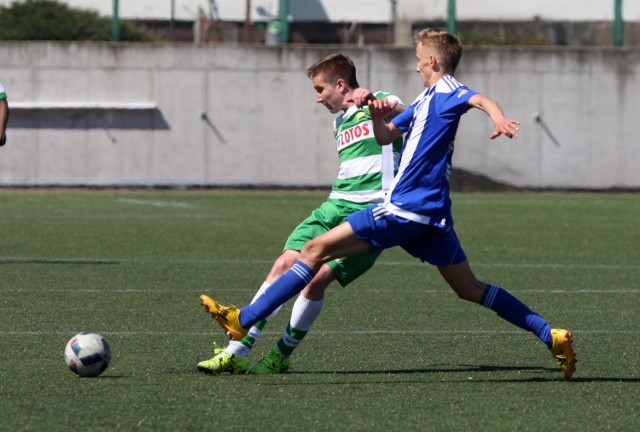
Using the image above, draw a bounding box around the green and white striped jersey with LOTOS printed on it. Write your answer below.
[329,91,402,207]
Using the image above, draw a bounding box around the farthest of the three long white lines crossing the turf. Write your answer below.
[0,256,640,270]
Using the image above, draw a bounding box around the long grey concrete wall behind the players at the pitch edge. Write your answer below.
[0,43,640,188]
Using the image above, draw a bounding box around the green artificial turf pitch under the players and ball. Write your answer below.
[0,190,640,432]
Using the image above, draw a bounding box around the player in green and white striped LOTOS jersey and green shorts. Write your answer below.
[198,54,404,374]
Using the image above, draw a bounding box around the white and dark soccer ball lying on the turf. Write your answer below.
[64,332,111,377]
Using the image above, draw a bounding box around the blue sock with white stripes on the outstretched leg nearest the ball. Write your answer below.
[239,261,315,328]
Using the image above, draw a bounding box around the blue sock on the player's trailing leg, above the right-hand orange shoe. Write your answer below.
[480,285,553,348]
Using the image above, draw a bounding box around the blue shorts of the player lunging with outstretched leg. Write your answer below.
[347,206,467,266]
